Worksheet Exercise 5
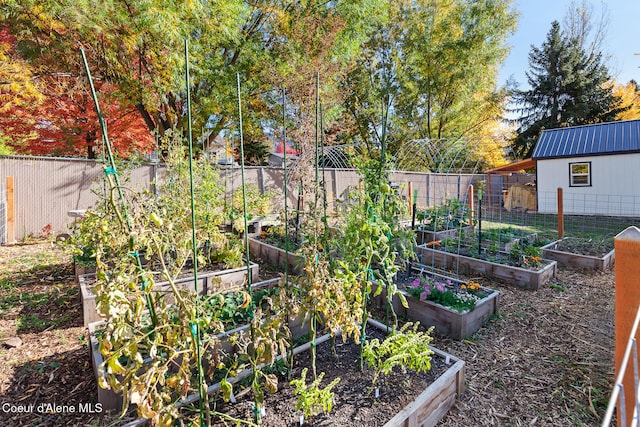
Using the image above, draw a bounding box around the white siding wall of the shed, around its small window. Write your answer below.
[537,153,640,216]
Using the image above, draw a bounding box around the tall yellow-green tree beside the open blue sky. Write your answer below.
[345,0,516,167]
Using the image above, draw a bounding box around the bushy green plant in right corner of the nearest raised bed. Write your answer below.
[363,322,433,386]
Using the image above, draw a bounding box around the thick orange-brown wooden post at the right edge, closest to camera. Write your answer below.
[614,227,640,426]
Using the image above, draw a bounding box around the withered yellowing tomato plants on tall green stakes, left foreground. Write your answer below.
[74,137,288,425]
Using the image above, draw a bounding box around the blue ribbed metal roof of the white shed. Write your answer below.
[531,120,640,159]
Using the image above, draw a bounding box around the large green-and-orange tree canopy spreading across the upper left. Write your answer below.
[4,0,384,163]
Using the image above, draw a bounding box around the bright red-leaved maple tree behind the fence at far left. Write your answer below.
[0,29,155,158]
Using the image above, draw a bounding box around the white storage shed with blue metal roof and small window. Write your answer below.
[532,120,640,216]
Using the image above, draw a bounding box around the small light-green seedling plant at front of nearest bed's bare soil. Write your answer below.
[290,368,340,420]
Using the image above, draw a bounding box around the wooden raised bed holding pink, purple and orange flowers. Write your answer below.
[374,266,500,340]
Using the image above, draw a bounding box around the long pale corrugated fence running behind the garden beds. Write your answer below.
[0,156,490,240]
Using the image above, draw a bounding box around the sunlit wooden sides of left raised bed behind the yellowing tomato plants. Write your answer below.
[78,262,260,327]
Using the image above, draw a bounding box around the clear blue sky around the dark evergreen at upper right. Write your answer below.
[499,0,640,89]
